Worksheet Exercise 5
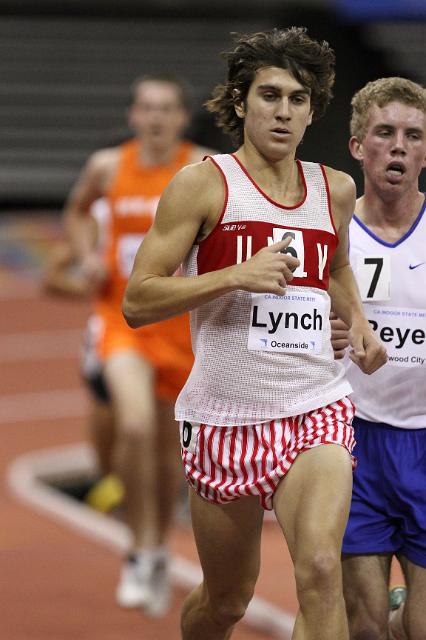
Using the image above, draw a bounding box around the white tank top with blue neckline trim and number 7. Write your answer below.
[347,196,426,429]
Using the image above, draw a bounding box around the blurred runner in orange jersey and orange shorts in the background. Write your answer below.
[65,75,215,615]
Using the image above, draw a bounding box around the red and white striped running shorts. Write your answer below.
[180,398,355,510]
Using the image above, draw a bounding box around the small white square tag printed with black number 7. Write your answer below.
[356,256,391,302]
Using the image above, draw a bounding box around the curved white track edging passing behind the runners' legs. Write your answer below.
[7,442,294,640]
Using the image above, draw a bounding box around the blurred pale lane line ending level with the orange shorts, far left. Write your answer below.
[0,329,84,363]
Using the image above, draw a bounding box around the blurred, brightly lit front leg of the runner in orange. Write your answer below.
[105,350,158,549]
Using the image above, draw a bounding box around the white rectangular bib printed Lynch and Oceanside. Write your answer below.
[247,292,328,354]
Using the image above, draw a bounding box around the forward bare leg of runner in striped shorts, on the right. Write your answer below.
[274,444,352,640]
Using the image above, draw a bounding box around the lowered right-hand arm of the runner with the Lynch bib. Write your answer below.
[327,169,387,373]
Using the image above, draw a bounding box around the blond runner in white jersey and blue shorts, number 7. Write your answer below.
[335,78,426,640]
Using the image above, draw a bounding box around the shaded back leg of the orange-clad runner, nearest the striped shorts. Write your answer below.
[156,399,184,544]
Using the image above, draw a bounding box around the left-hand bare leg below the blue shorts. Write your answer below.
[342,554,392,640]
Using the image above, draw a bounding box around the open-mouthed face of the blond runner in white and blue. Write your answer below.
[349,102,426,193]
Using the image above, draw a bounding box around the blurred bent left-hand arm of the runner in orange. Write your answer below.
[64,149,118,280]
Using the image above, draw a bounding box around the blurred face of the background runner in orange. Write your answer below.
[129,80,188,149]
